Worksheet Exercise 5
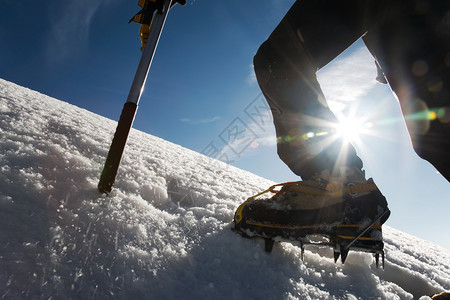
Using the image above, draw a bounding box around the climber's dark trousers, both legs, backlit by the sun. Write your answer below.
[254,0,450,180]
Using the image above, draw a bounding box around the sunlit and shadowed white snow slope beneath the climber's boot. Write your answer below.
[0,79,450,299]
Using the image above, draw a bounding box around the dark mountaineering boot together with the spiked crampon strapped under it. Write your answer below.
[234,167,390,260]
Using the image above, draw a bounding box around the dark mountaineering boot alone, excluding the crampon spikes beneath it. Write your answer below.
[236,168,389,232]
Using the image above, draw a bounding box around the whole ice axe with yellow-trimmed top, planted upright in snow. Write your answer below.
[98,0,186,193]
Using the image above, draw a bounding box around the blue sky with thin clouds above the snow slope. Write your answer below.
[0,0,450,249]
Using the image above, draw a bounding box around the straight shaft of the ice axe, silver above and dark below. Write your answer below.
[98,0,172,193]
